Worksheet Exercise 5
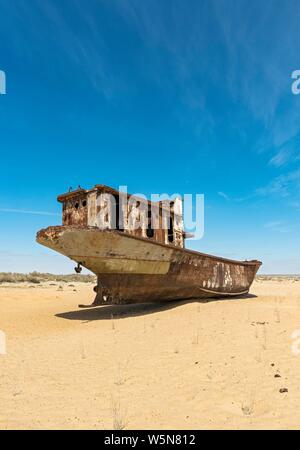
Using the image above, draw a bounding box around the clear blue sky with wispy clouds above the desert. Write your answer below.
[0,0,300,273]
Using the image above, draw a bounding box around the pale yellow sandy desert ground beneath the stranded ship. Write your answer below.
[0,279,300,429]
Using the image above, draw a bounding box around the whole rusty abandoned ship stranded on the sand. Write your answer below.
[37,185,261,306]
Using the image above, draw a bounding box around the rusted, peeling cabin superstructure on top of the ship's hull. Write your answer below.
[58,185,184,247]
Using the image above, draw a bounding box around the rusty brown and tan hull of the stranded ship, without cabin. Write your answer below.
[37,226,261,305]
